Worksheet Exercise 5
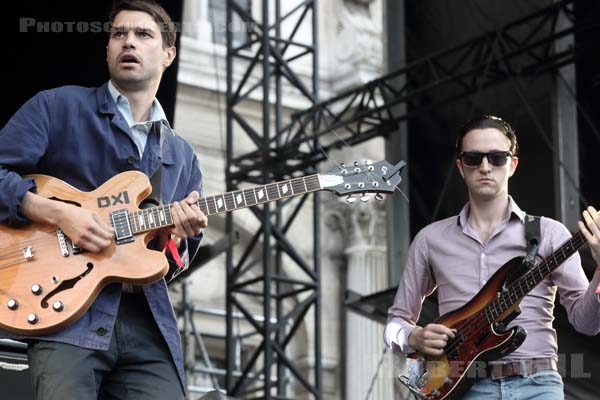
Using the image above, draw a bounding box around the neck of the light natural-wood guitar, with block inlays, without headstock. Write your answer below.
[129,174,323,234]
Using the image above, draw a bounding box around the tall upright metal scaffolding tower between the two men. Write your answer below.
[226,0,321,399]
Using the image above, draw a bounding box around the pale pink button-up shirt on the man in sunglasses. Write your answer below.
[384,198,600,361]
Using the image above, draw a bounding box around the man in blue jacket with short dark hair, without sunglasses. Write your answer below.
[0,0,207,400]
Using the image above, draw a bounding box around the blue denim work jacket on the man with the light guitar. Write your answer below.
[0,84,202,388]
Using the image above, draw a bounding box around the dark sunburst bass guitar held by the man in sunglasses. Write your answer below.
[400,219,586,400]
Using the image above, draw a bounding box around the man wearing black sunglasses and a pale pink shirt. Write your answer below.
[384,115,600,400]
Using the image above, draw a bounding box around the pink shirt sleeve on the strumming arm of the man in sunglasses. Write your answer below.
[384,230,435,354]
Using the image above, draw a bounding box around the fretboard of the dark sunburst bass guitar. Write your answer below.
[484,231,586,323]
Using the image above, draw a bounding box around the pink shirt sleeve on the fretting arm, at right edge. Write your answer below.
[542,223,600,336]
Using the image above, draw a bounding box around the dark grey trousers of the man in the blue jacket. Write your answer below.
[27,294,184,400]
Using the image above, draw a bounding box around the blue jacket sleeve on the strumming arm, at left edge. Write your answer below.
[0,92,50,225]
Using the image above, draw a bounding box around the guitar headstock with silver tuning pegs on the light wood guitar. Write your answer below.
[320,160,406,203]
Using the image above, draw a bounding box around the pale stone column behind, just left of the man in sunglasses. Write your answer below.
[326,200,394,400]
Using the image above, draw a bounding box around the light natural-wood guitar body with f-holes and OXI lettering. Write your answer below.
[0,171,168,335]
